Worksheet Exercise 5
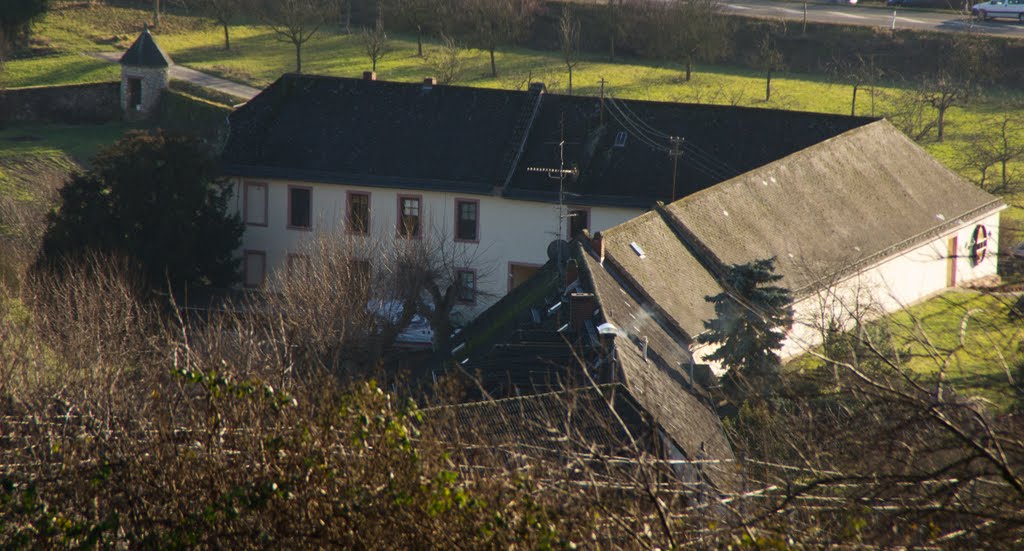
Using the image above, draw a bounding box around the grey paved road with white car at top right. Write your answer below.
[723,0,1024,38]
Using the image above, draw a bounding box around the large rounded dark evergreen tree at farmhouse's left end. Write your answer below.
[40,130,243,290]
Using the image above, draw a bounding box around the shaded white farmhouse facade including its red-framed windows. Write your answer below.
[233,178,643,317]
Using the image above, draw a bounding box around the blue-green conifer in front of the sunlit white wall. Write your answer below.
[697,258,793,389]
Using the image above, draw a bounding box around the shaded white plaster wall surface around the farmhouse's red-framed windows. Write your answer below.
[233,179,644,316]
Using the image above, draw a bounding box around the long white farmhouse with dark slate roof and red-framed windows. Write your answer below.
[222,74,888,316]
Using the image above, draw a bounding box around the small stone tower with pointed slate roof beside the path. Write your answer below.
[121,28,174,120]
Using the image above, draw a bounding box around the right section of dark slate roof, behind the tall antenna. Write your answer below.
[506,94,873,208]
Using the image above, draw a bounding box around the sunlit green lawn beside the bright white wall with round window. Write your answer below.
[786,291,1024,410]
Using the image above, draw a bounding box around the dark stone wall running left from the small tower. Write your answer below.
[0,82,121,124]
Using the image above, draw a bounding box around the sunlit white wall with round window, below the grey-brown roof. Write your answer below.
[693,212,999,375]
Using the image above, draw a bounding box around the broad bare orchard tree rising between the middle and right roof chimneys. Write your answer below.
[459,0,540,77]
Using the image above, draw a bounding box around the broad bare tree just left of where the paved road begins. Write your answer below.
[650,0,732,82]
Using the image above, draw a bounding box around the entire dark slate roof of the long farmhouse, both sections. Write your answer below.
[222,75,871,208]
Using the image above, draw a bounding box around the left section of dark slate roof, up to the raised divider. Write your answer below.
[222,74,534,194]
